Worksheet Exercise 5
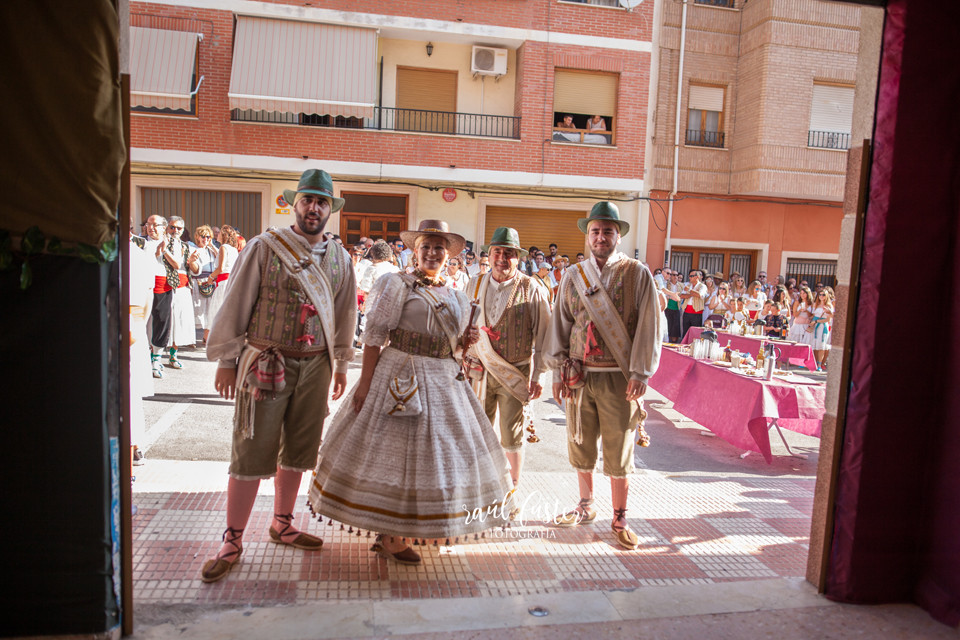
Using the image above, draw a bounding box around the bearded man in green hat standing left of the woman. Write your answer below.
[200,169,357,582]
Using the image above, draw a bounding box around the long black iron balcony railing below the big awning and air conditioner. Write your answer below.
[230,107,520,140]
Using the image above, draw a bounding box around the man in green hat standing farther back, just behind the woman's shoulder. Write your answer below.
[466,227,550,486]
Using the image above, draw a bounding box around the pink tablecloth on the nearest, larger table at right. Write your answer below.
[649,348,825,464]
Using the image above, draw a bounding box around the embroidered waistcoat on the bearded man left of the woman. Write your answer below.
[247,243,343,356]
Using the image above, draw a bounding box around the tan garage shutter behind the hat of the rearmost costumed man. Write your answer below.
[480,207,587,262]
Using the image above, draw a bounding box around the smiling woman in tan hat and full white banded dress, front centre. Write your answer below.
[309,220,513,564]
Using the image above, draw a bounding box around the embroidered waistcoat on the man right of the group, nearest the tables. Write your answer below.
[565,259,644,367]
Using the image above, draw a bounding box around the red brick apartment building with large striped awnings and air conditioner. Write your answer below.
[129,0,652,257]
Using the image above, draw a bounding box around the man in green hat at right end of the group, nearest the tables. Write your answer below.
[544,202,661,550]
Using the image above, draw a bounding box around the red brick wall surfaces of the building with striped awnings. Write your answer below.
[130,0,653,179]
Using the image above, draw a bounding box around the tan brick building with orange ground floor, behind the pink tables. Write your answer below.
[646,0,880,286]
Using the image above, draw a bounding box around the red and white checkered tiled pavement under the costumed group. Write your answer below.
[133,460,814,607]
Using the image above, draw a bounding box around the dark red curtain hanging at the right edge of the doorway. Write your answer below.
[827,0,960,625]
